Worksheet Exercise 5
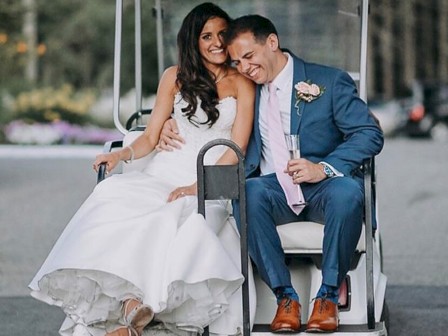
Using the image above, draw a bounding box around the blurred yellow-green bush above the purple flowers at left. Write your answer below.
[12,85,95,124]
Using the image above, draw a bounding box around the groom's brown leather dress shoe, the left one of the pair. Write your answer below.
[271,298,302,332]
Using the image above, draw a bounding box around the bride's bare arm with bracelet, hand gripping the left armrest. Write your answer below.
[93,66,177,172]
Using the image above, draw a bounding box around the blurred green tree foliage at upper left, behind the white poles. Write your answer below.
[0,0,158,94]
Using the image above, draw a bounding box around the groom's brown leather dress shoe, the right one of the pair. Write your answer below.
[306,298,339,333]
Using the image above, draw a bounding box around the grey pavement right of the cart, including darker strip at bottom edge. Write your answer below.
[377,139,448,336]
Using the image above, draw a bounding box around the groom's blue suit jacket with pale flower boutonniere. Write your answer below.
[246,53,383,186]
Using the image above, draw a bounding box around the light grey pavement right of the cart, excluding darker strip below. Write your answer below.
[377,139,448,286]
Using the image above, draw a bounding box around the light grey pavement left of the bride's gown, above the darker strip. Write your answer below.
[0,147,101,296]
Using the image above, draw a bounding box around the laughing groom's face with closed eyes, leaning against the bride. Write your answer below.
[227,32,278,84]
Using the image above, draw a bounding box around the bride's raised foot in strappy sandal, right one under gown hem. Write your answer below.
[120,299,154,336]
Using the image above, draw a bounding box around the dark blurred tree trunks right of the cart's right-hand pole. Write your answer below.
[368,0,448,99]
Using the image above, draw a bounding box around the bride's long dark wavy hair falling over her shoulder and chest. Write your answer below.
[176,2,231,126]
